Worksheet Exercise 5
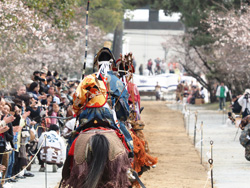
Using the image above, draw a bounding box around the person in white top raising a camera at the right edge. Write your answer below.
[238,89,250,118]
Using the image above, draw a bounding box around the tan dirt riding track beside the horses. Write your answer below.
[141,101,211,188]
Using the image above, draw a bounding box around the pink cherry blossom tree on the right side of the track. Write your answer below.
[164,5,250,101]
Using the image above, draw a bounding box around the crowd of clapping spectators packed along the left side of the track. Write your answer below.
[0,66,79,187]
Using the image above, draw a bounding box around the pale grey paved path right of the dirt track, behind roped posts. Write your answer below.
[167,104,250,188]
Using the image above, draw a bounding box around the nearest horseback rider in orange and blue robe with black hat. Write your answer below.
[73,47,133,156]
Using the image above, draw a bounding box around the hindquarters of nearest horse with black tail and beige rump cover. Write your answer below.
[61,119,131,188]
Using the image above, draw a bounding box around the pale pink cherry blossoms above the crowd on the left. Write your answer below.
[0,0,105,88]
